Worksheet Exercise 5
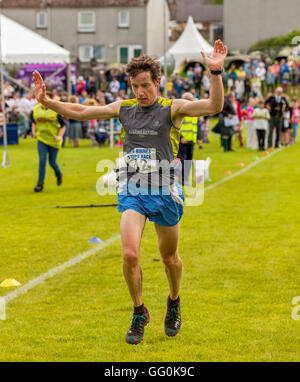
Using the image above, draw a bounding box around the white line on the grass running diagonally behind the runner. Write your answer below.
[0,148,283,320]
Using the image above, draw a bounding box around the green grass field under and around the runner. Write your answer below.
[0,124,300,362]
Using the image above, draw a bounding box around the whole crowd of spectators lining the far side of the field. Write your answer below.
[0,57,300,151]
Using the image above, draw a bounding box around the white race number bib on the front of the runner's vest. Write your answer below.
[124,148,157,174]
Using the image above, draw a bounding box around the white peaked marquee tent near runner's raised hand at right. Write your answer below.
[168,16,214,72]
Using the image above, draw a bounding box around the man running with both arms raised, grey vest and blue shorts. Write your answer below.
[33,40,227,344]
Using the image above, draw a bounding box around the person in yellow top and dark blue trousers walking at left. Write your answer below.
[31,103,66,192]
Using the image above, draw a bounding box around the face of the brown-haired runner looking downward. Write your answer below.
[130,71,160,107]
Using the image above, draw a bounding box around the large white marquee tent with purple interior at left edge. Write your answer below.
[0,15,70,167]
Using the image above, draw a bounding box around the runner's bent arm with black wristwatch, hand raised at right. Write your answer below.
[172,40,227,118]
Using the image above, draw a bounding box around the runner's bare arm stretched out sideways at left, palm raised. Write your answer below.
[33,70,122,121]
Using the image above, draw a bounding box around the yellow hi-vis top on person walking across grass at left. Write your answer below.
[33,103,62,149]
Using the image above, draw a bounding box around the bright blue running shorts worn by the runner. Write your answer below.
[118,181,184,227]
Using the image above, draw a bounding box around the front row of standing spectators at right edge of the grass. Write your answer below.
[212,86,300,152]
